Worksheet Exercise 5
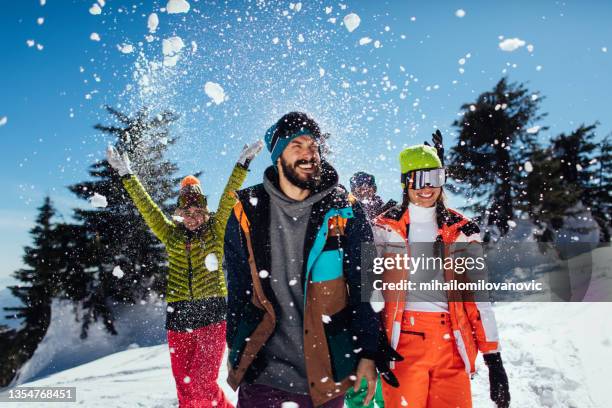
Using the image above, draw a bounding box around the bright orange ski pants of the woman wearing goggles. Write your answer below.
[383,310,472,408]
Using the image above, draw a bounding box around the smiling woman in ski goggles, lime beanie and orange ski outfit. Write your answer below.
[373,132,510,408]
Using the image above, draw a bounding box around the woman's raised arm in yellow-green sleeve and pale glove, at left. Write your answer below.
[106,146,174,243]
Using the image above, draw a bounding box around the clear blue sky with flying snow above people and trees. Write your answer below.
[0,0,612,289]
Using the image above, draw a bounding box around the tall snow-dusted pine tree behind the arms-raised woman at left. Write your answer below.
[66,107,178,338]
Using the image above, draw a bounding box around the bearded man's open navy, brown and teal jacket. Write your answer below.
[225,164,380,406]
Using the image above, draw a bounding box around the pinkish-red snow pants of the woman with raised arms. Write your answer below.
[168,321,233,408]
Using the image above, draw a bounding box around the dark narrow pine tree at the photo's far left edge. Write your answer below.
[0,197,63,387]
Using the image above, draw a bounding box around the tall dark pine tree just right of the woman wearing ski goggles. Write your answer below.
[449,78,546,235]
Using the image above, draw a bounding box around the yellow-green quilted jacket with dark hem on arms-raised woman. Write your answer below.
[123,164,247,331]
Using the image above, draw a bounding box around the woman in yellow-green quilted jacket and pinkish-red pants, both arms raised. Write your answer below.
[107,141,263,408]
